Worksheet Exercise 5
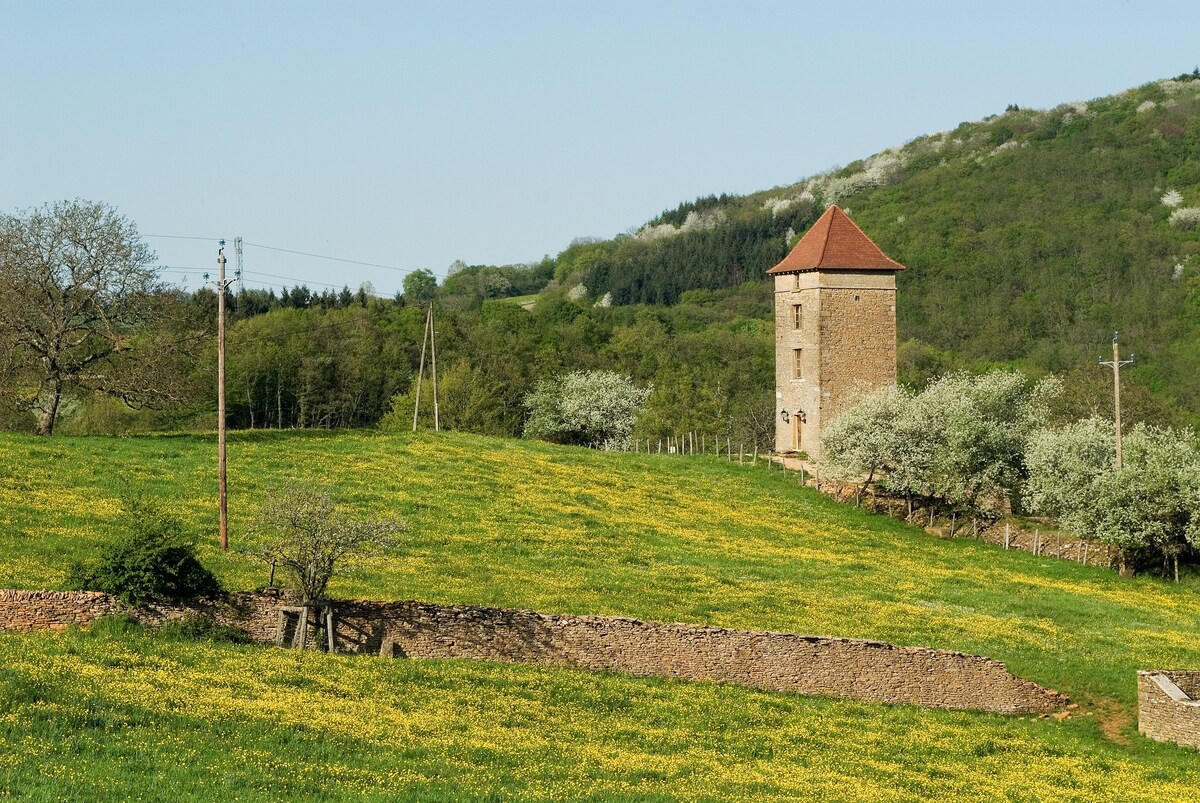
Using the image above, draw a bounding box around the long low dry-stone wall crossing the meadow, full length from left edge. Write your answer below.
[0,592,1068,713]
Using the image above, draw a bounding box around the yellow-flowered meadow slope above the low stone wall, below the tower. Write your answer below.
[0,432,1200,706]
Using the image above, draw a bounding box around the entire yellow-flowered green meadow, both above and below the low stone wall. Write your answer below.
[0,432,1200,801]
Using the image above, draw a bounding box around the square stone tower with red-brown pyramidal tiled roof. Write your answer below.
[767,206,904,459]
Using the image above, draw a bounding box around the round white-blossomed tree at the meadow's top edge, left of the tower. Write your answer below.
[524,371,652,448]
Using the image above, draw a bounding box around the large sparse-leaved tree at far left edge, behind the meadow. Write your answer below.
[0,199,187,435]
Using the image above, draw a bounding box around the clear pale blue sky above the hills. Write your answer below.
[0,0,1200,294]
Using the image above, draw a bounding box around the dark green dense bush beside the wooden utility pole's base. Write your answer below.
[67,497,221,605]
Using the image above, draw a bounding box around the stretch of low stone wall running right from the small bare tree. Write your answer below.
[357,603,1067,713]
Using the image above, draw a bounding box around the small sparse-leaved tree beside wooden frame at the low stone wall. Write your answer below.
[246,485,406,605]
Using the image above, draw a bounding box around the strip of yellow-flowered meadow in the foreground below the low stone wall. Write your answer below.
[0,634,1200,802]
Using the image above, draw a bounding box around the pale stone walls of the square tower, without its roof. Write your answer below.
[775,270,896,459]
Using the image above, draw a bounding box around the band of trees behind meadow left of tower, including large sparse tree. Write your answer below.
[0,202,773,444]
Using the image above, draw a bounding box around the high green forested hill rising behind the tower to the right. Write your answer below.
[556,73,1200,418]
